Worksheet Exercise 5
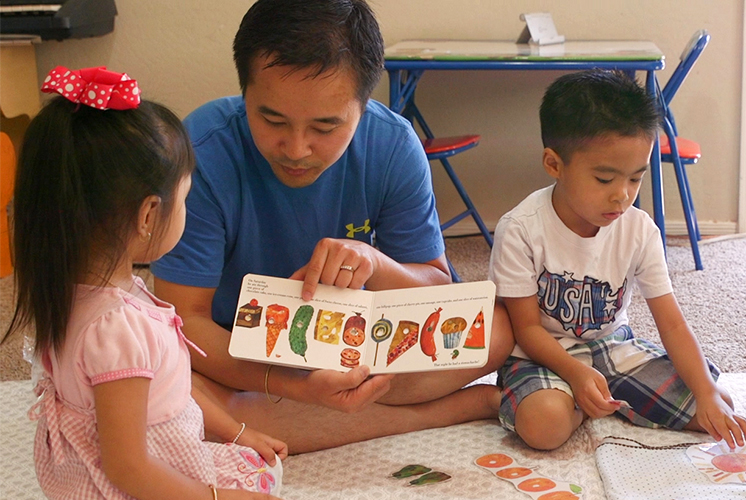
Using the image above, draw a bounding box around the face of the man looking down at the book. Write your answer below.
[244,58,362,188]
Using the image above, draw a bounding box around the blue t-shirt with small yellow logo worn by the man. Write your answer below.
[151,96,445,327]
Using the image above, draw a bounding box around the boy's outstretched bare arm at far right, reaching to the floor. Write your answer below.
[647,293,746,448]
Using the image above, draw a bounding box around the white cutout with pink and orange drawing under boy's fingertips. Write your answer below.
[686,443,746,484]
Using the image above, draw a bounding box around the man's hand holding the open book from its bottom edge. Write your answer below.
[299,365,393,413]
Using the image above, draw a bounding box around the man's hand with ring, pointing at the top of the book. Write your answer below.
[290,238,380,300]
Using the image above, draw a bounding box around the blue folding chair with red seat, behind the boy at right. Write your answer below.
[653,30,710,270]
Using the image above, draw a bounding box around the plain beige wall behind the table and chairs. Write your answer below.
[26,0,744,233]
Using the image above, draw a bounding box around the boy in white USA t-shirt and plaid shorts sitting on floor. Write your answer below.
[490,70,746,450]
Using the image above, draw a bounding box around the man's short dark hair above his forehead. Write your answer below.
[233,0,383,105]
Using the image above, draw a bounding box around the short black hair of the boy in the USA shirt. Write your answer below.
[539,70,661,162]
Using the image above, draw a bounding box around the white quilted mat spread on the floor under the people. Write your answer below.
[0,373,746,500]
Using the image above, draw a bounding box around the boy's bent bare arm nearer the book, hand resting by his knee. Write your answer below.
[503,295,618,418]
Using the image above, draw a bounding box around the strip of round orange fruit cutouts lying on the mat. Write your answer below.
[474,453,583,500]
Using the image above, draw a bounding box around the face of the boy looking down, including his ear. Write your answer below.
[544,134,653,238]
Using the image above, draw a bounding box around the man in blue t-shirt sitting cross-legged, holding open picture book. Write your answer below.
[152,0,512,452]
